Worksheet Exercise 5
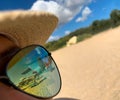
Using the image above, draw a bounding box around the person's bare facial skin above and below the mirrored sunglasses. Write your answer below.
[0,35,52,100]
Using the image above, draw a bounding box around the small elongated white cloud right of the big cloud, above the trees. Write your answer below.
[76,7,92,22]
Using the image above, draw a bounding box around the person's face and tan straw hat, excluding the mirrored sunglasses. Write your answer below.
[0,10,61,100]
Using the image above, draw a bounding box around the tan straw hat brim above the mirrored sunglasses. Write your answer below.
[0,10,58,47]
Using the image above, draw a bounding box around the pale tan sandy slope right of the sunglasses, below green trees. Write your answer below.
[52,27,120,100]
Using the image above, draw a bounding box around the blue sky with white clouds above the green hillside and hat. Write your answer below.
[0,0,120,40]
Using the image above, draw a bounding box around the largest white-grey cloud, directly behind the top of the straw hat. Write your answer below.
[31,0,92,25]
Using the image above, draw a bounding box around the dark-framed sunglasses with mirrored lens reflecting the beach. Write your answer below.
[0,45,61,99]
